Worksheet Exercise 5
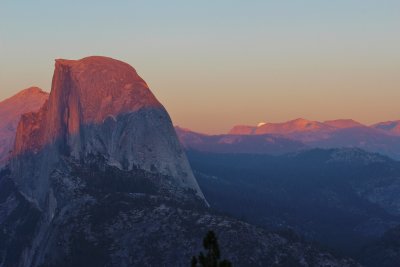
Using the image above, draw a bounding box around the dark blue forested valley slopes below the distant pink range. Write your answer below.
[188,148,400,260]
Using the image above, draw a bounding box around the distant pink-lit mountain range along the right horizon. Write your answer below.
[176,119,400,159]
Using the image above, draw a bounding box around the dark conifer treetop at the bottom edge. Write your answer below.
[191,231,232,267]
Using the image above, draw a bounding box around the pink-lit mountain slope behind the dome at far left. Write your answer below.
[0,87,49,166]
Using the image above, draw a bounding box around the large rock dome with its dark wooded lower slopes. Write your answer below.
[0,57,357,267]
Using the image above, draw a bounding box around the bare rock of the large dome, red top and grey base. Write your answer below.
[11,56,203,204]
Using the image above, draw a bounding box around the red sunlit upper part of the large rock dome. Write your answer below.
[14,57,163,155]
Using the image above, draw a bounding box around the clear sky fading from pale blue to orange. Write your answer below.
[0,0,400,133]
